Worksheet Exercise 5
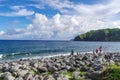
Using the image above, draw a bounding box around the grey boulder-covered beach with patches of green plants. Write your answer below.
[0,53,120,80]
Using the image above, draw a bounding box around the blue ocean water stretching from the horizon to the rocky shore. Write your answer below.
[0,40,120,62]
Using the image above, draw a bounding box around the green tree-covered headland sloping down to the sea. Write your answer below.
[74,28,120,41]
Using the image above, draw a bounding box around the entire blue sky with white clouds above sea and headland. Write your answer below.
[0,0,120,40]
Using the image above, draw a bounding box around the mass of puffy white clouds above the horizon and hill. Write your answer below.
[0,0,120,40]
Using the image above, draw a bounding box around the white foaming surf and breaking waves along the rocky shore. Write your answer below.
[0,51,89,63]
